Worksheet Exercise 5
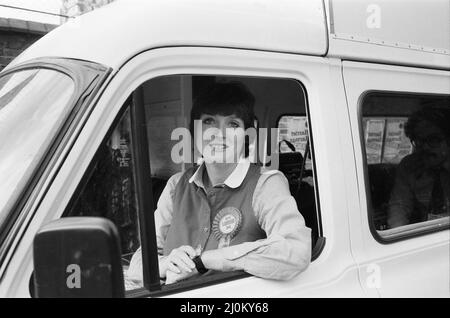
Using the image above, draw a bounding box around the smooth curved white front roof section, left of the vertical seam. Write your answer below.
[3,0,327,69]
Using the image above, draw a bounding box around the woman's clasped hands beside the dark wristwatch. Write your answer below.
[159,245,197,278]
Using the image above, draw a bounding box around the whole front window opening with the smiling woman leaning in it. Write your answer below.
[56,71,318,293]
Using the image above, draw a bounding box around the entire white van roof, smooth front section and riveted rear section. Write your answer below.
[8,0,450,69]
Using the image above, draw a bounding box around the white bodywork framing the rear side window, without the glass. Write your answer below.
[343,61,450,297]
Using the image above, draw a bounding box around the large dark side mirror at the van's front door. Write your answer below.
[33,217,125,298]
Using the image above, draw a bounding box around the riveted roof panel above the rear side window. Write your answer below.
[325,0,450,69]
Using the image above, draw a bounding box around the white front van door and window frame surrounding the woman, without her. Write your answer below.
[4,47,365,297]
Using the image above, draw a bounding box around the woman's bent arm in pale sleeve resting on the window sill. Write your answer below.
[201,171,311,280]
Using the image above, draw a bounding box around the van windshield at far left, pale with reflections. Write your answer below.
[0,69,75,226]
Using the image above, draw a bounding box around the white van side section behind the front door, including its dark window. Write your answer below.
[343,61,450,297]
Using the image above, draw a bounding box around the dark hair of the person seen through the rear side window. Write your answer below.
[405,107,450,141]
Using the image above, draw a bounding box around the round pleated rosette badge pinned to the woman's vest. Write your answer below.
[212,207,242,248]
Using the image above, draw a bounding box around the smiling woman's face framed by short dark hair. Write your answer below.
[195,114,245,163]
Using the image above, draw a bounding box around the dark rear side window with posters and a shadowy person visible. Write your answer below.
[361,93,450,241]
